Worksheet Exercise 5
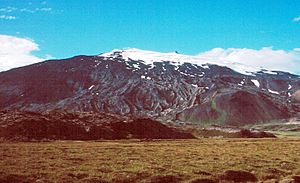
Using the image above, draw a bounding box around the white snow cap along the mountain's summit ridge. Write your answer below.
[99,48,272,75]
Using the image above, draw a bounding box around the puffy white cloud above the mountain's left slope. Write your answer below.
[0,34,50,72]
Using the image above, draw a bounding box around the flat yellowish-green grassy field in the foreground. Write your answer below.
[0,138,300,183]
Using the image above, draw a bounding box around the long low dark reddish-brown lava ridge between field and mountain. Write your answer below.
[0,111,194,140]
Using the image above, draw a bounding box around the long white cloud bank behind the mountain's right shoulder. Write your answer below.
[198,47,300,73]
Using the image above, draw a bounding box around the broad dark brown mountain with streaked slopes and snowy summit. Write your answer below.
[0,49,300,126]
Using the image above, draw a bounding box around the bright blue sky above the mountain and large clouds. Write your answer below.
[0,0,300,73]
